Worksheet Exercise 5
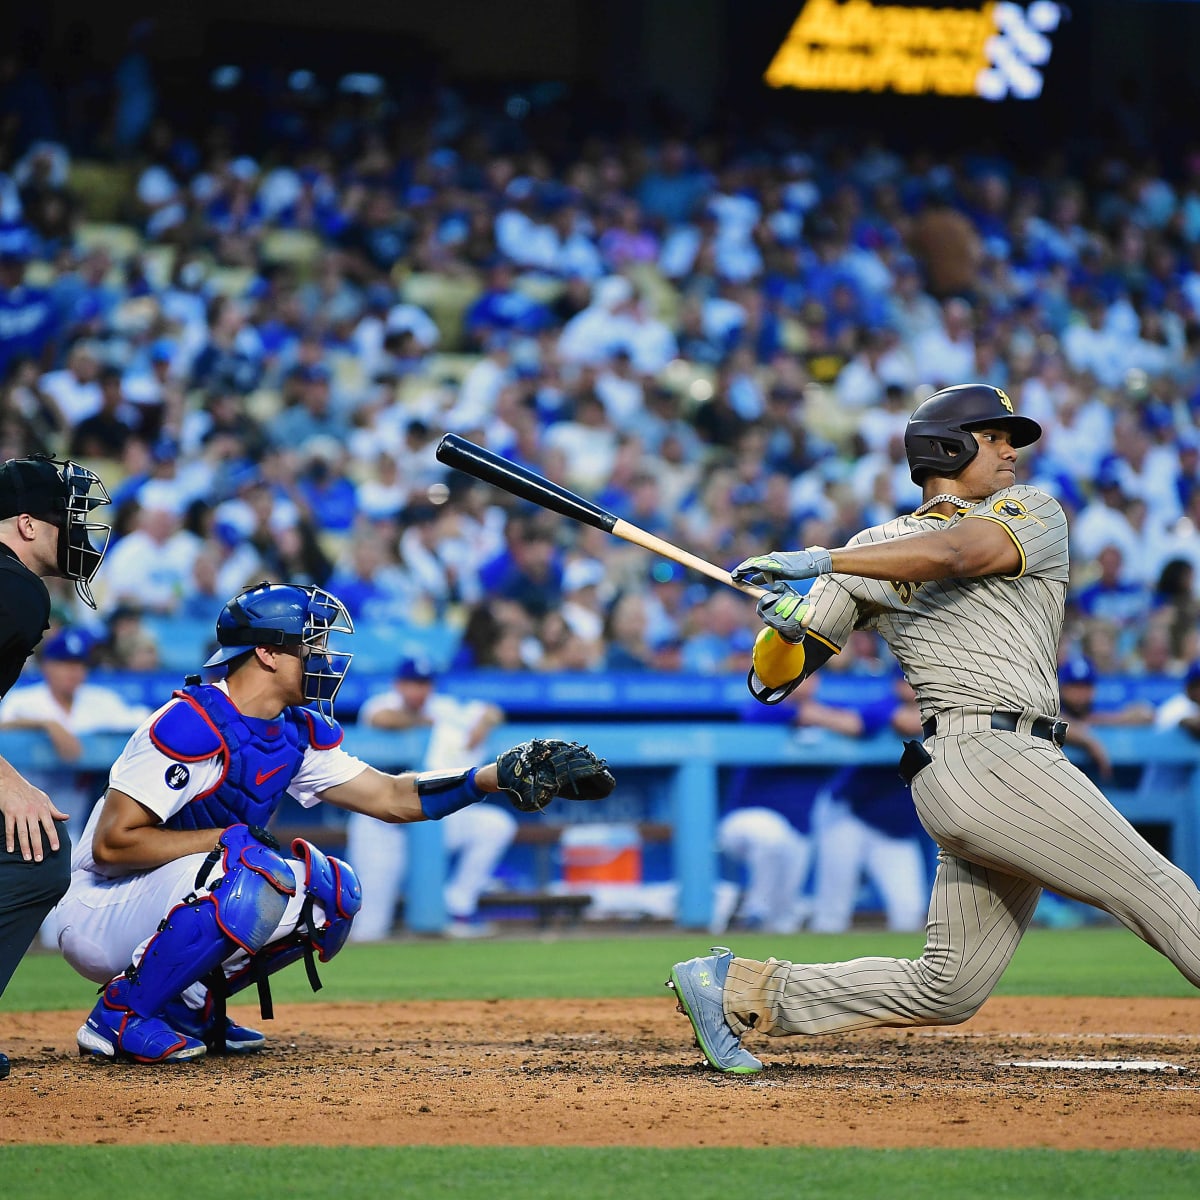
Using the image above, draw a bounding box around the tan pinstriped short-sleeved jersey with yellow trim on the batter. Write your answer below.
[808,485,1068,718]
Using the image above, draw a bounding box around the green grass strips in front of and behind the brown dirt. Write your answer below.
[0,929,1200,1200]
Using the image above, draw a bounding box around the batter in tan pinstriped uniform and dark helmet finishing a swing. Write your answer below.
[670,384,1200,1074]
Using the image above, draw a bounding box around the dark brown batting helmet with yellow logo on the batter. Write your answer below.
[904,383,1042,484]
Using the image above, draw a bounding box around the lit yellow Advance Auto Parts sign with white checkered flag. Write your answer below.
[763,0,1063,100]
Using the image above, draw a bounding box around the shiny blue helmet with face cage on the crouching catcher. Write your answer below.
[204,582,354,716]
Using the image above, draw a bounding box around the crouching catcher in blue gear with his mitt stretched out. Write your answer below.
[58,583,613,1063]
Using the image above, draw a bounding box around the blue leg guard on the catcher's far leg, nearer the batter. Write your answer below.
[224,838,362,1020]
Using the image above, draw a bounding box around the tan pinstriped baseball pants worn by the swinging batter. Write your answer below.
[725,731,1200,1036]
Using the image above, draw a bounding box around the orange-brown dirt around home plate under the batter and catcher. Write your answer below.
[0,991,1200,1150]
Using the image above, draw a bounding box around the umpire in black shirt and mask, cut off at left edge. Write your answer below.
[0,457,109,1079]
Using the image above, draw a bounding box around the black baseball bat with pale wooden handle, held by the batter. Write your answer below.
[437,433,763,596]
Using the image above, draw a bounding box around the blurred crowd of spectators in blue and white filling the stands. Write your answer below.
[0,51,1200,696]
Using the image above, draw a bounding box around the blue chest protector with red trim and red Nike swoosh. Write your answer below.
[150,684,342,829]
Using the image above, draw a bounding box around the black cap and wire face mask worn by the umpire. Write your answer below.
[0,455,112,608]
